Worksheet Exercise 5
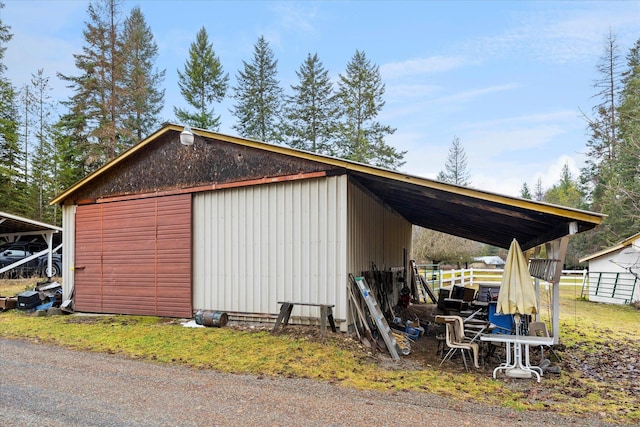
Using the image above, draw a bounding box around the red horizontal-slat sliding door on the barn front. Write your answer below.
[74,194,192,317]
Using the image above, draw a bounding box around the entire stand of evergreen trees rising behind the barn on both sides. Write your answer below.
[0,0,640,268]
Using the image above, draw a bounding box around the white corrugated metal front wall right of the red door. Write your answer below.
[193,176,347,326]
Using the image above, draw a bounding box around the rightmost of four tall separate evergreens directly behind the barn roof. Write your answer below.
[336,50,406,169]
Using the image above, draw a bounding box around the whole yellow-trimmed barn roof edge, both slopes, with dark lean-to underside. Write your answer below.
[51,124,606,250]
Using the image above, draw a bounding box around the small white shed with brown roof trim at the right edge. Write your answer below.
[580,233,640,304]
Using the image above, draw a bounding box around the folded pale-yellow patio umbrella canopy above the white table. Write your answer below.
[496,239,538,314]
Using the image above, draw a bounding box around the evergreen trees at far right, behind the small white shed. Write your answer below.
[520,32,640,268]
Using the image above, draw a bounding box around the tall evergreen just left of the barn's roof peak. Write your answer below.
[122,6,166,142]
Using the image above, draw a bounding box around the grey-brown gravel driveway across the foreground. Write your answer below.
[0,339,620,427]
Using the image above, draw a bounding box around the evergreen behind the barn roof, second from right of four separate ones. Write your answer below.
[285,54,338,155]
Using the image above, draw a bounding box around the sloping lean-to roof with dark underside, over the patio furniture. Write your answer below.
[344,171,605,250]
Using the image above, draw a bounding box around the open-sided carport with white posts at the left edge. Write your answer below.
[0,212,62,280]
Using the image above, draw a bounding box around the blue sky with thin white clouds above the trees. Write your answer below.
[5,0,640,196]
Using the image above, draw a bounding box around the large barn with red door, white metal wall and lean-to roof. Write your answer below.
[52,124,603,342]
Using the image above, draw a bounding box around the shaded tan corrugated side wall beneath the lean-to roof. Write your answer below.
[347,178,411,276]
